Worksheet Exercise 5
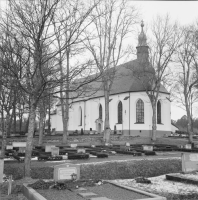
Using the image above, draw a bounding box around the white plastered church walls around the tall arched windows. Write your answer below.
[51,92,171,137]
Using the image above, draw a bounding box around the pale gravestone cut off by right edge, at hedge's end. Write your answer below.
[181,153,198,173]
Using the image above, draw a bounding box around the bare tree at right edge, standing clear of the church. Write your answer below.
[175,26,198,143]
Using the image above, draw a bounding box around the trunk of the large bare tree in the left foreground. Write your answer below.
[24,98,36,177]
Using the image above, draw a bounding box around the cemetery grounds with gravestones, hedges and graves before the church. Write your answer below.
[0,142,198,200]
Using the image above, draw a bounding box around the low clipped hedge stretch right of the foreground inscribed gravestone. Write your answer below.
[81,159,181,179]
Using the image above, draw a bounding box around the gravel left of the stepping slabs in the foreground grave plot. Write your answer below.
[36,189,85,200]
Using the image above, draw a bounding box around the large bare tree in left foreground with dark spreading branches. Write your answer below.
[0,0,100,177]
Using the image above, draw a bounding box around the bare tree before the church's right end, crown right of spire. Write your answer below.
[133,15,180,141]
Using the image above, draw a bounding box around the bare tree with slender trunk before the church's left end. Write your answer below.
[54,0,98,143]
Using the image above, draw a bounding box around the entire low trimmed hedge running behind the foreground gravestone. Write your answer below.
[4,159,182,180]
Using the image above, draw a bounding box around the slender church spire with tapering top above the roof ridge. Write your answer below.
[136,21,149,62]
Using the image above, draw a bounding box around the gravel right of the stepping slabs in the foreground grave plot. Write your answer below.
[86,183,149,200]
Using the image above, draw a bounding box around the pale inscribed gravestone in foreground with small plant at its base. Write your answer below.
[54,164,80,182]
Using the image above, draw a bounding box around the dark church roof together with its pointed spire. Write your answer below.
[55,21,169,104]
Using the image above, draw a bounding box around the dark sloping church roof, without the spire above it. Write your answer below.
[68,59,169,101]
